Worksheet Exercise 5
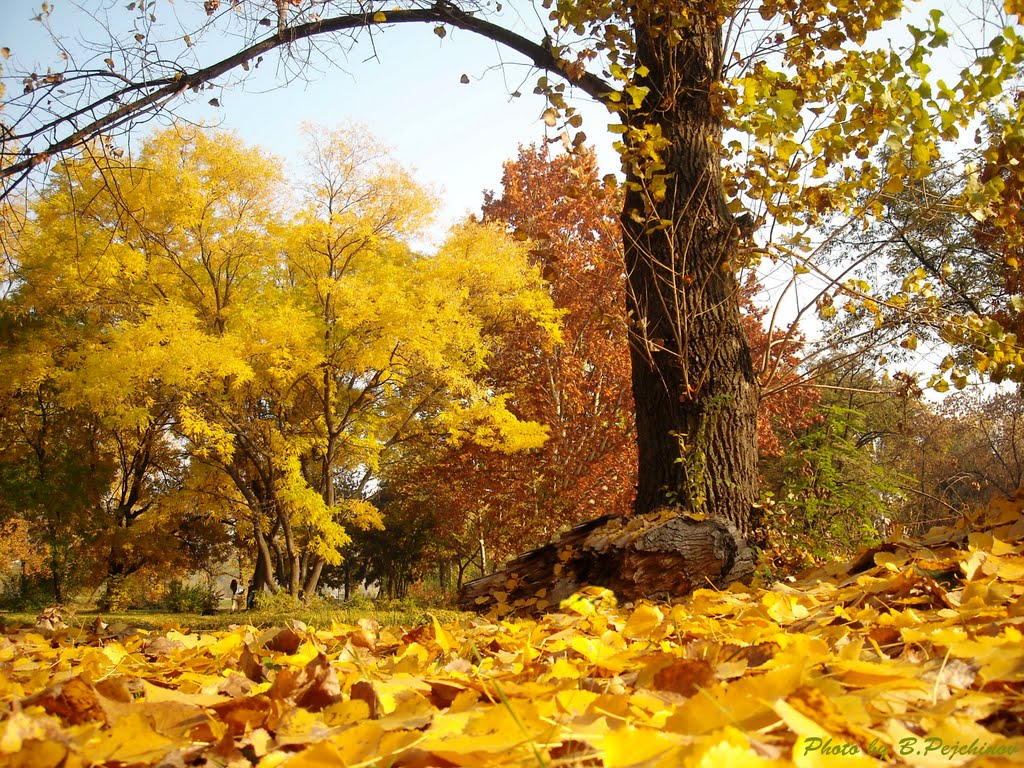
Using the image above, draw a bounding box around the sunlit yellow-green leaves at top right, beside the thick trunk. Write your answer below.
[723,2,1022,270]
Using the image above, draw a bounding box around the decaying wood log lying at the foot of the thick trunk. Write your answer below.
[459,508,754,615]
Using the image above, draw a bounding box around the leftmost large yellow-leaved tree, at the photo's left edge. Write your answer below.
[4,126,272,599]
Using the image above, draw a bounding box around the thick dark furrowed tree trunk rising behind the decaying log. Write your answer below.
[622,13,758,535]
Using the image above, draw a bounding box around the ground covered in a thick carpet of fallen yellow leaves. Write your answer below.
[0,502,1024,768]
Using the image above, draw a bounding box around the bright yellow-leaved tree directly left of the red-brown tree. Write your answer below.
[274,127,557,593]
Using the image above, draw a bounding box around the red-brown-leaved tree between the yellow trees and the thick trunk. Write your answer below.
[384,146,636,586]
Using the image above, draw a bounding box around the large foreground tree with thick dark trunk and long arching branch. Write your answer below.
[3,0,1024,606]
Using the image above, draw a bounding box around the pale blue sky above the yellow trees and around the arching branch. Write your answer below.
[0,0,617,233]
